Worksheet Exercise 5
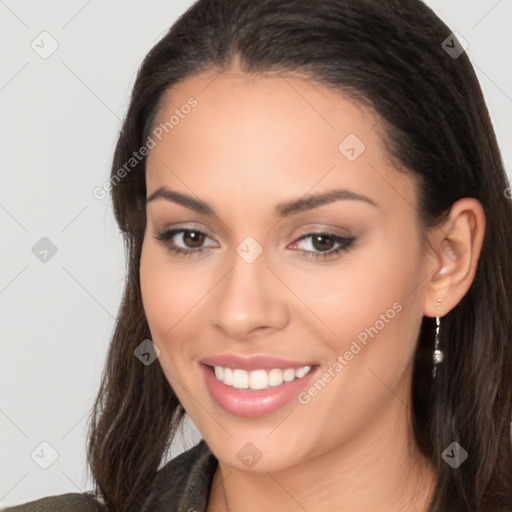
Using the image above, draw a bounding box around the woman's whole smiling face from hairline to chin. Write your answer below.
[140,71,434,471]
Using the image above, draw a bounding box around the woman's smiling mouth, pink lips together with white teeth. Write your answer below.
[200,363,319,418]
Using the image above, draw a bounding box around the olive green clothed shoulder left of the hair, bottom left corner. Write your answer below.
[0,493,105,512]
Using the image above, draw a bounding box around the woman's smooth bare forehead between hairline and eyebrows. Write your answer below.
[146,71,415,216]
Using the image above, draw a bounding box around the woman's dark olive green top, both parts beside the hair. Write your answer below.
[2,440,217,512]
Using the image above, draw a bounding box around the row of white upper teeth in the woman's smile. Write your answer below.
[214,366,311,390]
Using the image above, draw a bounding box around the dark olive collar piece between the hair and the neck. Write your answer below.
[141,440,218,512]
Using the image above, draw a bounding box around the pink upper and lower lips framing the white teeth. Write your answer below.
[200,359,320,418]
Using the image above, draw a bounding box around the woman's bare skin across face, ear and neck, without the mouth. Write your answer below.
[140,61,485,512]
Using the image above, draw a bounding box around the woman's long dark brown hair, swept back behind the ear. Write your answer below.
[88,0,512,512]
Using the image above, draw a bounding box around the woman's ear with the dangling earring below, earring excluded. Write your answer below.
[423,197,485,317]
